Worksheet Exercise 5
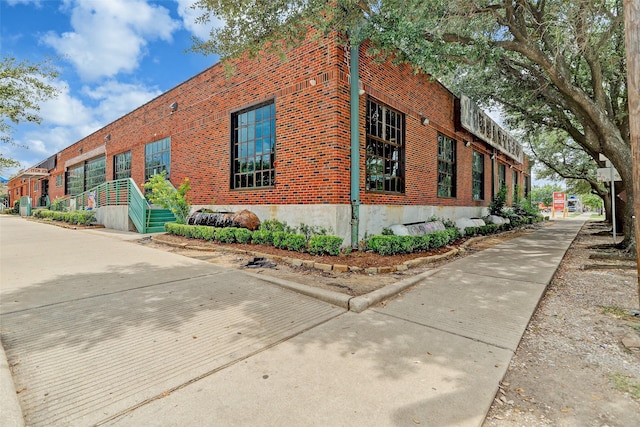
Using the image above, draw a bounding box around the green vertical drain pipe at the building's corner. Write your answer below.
[349,41,360,249]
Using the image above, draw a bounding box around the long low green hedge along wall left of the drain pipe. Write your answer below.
[164,222,343,255]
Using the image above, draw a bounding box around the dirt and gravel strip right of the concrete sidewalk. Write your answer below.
[484,222,640,427]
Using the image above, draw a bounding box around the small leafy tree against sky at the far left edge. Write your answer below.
[0,57,58,167]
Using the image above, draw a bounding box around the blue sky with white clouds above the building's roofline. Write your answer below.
[0,0,218,176]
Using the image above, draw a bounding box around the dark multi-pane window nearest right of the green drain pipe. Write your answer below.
[366,99,405,193]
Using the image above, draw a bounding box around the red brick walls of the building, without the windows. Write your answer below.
[9,33,529,241]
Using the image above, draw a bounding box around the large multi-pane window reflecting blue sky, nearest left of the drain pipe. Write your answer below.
[231,102,276,189]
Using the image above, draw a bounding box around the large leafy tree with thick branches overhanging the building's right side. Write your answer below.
[194,0,635,249]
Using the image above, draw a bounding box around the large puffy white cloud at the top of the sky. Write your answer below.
[43,0,180,81]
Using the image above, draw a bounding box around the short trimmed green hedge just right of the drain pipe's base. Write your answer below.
[366,228,460,255]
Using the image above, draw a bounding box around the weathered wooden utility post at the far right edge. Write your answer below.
[623,0,640,307]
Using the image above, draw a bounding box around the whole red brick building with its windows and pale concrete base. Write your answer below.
[9,38,530,241]
